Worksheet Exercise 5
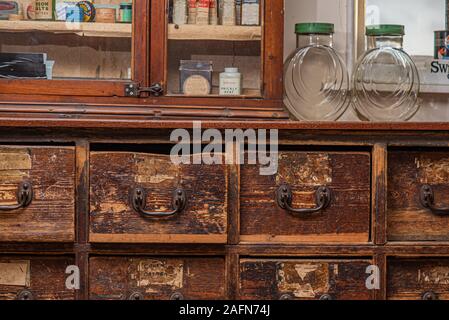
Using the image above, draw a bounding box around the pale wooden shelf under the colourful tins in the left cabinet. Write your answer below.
[0,20,132,38]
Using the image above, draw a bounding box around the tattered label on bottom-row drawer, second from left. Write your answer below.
[130,259,184,292]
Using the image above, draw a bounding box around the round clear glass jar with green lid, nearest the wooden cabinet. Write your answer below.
[284,23,349,121]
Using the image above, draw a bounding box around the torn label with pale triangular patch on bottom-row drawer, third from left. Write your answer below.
[277,263,329,298]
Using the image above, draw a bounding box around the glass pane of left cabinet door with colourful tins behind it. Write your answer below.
[0,0,144,95]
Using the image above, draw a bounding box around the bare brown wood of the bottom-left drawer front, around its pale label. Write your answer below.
[0,256,75,300]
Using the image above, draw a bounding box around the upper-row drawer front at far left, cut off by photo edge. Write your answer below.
[0,146,75,242]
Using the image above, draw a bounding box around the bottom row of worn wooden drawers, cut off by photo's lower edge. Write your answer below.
[0,256,449,300]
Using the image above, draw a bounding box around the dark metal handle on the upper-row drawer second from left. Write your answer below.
[131,188,187,218]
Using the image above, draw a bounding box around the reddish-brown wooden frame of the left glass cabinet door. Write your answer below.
[0,0,150,97]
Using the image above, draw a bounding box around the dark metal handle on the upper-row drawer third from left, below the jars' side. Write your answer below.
[276,184,332,215]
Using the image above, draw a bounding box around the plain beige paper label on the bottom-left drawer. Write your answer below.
[0,261,30,287]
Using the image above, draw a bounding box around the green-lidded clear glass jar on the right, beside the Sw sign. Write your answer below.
[352,25,420,121]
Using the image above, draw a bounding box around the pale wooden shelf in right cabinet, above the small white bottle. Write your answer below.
[168,24,262,41]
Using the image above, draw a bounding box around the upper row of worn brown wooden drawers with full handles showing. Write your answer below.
[0,146,449,243]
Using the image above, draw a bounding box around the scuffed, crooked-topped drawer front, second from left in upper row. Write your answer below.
[90,152,228,243]
